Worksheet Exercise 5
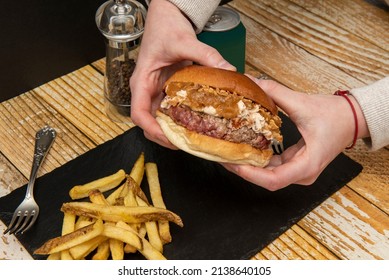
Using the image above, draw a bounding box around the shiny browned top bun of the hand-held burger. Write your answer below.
[164,65,278,115]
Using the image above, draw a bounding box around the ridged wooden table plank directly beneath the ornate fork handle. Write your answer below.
[0,92,95,178]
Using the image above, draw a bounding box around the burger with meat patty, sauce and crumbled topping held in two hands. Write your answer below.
[156,65,282,167]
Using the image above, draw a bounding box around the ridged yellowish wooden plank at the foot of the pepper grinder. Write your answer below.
[34,66,133,144]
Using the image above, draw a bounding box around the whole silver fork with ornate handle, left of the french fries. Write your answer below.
[4,126,56,234]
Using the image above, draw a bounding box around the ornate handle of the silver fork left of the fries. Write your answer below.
[26,125,57,197]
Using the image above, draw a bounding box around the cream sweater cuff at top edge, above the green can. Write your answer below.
[169,0,221,33]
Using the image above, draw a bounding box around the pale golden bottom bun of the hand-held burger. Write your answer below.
[156,111,273,167]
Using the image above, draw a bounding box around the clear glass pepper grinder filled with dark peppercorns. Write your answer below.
[96,0,146,123]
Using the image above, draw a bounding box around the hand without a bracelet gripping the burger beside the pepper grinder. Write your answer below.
[130,0,235,149]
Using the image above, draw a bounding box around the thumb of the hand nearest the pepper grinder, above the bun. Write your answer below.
[180,40,236,71]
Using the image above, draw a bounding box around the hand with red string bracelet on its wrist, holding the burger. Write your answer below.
[222,79,369,191]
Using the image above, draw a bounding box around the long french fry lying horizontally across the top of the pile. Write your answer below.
[61,202,184,227]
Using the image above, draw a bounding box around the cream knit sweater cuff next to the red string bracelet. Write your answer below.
[350,77,389,151]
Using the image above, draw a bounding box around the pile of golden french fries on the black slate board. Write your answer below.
[34,152,183,260]
